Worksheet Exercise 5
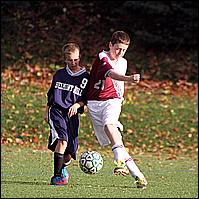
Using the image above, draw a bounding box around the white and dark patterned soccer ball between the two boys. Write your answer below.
[79,151,103,174]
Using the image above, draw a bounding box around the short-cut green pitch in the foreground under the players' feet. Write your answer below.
[1,145,198,198]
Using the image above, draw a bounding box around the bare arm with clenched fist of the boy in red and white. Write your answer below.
[107,69,140,83]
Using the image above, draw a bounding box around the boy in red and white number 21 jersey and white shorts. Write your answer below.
[87,31,147,188]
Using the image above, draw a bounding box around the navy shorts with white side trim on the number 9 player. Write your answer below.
[48,107,79,160]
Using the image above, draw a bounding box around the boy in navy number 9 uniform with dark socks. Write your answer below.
[45,42,89,185]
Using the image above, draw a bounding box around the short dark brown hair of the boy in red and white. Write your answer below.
[110,31,130,45]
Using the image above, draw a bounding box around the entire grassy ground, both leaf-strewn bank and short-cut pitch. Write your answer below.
[1,70,198,198]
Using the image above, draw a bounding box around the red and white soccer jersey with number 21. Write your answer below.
[87,51,127,101]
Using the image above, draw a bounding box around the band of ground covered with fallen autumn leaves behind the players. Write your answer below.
[1,64,198,159]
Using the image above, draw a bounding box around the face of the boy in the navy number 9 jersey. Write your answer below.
[65,50,80,67]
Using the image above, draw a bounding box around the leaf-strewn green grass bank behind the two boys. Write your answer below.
[1,79,198,154]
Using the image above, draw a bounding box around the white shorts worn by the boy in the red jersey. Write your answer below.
[87,99,123,147]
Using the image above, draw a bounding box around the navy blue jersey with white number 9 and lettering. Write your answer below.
[47,67,89,112]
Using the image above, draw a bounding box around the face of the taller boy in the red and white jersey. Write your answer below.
[109,42,129,59]
